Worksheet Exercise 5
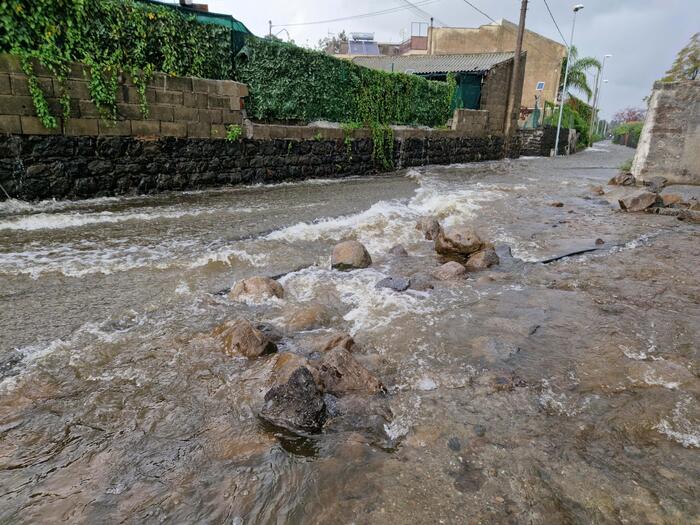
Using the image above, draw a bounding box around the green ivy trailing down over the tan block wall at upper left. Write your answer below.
[0,0,233,128]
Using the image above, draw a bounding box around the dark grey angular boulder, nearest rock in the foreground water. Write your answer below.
[260,366,326,433]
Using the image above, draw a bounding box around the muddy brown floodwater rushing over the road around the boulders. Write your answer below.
[0,144,700,524]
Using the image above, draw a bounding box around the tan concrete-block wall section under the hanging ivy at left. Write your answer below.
[0,54,248,138]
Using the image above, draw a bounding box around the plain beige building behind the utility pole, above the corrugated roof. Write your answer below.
[427,20,566,108]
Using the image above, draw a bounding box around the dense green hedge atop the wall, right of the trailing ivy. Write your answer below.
[235,38,454,126]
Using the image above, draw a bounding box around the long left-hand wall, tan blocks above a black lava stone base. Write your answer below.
[0,55,518,200]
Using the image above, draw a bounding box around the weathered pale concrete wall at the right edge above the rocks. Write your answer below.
[632,80,700,184]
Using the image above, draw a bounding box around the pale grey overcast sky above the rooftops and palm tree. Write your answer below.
[199,0,700,118]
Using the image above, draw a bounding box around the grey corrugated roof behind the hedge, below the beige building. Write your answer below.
[352,52,515,74]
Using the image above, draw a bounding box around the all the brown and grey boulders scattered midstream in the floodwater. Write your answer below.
[211,217,499,435]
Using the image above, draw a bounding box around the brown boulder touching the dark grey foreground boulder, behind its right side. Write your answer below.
[318,347,384,396]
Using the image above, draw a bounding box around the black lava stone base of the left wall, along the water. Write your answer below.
[0,135,504,200]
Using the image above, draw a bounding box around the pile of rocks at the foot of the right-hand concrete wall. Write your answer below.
[608,173,700,222]
